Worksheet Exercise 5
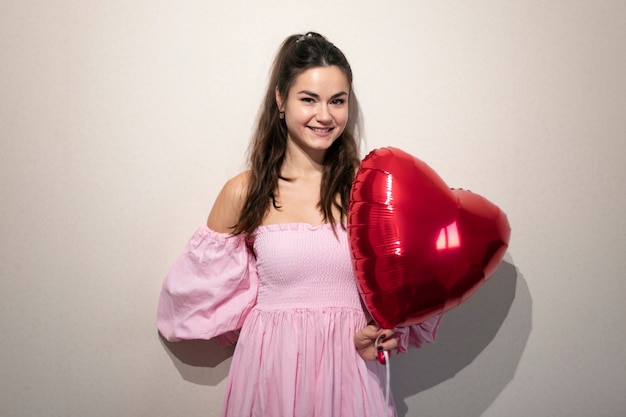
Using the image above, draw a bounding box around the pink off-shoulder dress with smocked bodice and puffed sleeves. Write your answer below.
[157,223,440,417]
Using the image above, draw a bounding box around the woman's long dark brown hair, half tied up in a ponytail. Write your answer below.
[233,32,360,234]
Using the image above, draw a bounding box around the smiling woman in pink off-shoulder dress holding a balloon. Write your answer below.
[158,33,439,417]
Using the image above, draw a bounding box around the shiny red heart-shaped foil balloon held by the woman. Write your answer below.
[348,148,511,328]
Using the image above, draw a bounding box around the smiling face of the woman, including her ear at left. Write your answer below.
[276,66,350,158]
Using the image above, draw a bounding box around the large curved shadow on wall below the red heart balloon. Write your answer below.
[390,255,532,417]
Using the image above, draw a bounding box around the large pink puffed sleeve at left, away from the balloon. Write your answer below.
[157,226,259,345]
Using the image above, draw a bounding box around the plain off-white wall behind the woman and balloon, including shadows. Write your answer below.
[0,0,626,417]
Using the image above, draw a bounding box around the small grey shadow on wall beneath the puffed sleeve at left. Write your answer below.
[159,335,234,386]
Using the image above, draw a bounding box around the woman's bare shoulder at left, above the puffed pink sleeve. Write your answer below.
[207,171,251,233]
